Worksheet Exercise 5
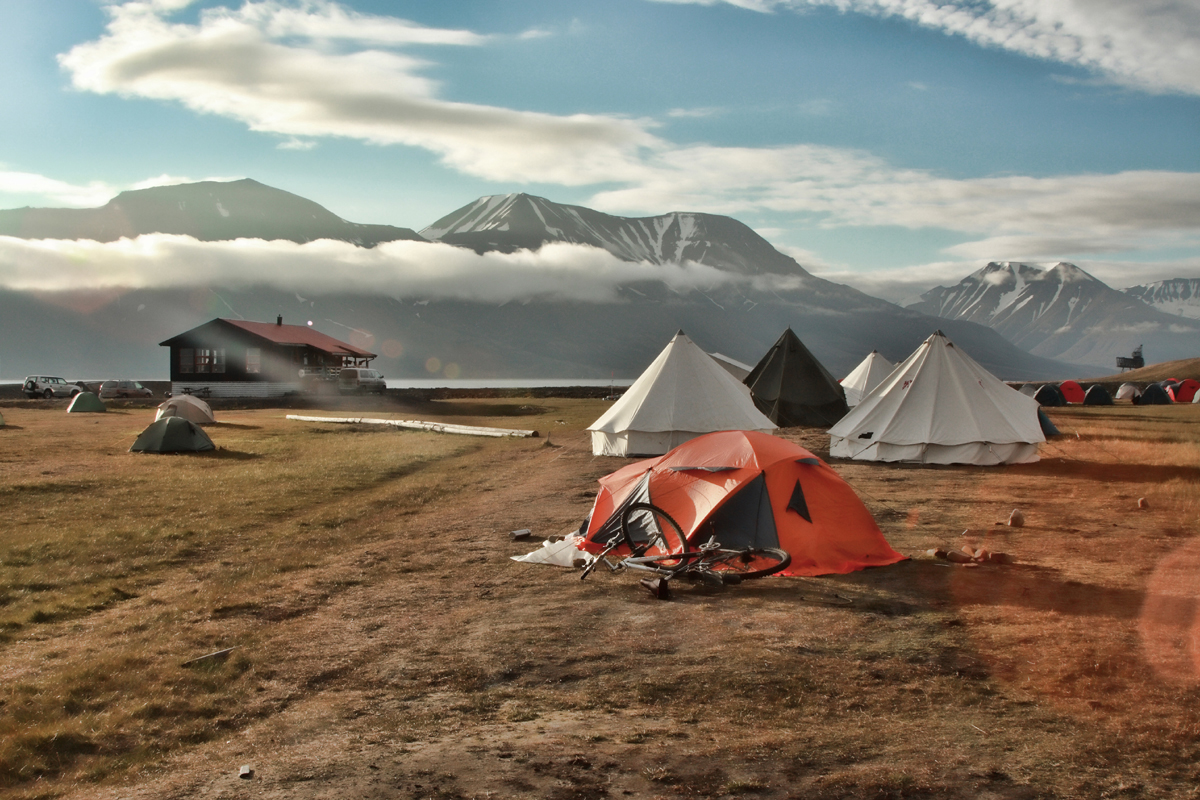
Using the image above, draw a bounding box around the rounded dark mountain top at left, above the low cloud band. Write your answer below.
[0,179,421,247]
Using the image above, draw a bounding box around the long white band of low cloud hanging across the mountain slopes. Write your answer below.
[0,234,738,303]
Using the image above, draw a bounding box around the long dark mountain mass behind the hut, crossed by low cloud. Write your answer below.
[0,181,1081,380]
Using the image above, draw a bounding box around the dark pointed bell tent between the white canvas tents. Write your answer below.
[745,327,850,427]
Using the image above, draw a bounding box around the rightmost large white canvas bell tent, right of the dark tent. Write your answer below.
[829,331,1045,464]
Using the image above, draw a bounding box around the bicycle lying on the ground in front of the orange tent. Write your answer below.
[580,503,792,600]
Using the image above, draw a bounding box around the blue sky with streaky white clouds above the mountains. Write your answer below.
[0,0,1200,301]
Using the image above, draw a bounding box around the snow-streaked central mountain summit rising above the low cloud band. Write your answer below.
[420,194,812,277]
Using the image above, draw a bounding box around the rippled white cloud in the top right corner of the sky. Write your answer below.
[670,0,1200,95]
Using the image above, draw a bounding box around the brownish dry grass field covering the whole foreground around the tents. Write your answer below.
[0,401,1200,799]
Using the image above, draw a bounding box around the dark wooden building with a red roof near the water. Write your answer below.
[158,317,376,397]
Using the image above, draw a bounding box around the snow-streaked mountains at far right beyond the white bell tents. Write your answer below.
[908,261,1200,367]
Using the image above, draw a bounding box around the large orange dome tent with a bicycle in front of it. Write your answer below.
[580,431,905,576]
